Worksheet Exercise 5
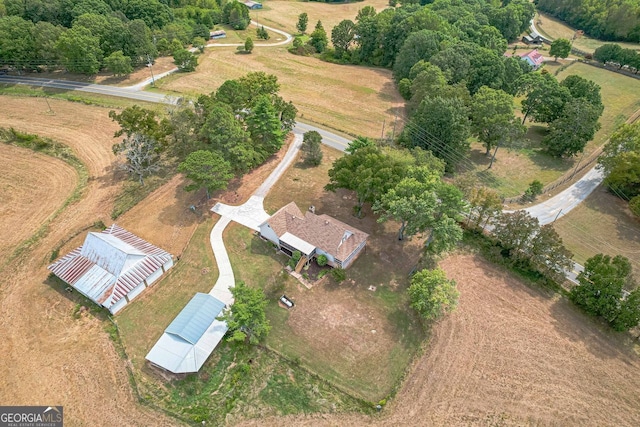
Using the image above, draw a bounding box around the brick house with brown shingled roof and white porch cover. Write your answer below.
[259,202,369,268]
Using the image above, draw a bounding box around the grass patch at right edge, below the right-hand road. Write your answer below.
[554,186,640,283]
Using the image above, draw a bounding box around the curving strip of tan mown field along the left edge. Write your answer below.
[0,96,175,426]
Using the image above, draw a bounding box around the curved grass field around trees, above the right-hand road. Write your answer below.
[471,62,640,197]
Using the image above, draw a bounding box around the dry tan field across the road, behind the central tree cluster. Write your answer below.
[157,47,403,137]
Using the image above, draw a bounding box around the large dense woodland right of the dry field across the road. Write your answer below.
[290,1,603,172]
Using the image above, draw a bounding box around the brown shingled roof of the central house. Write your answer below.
[267,202,369,261]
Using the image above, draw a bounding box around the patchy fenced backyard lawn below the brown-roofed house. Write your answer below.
[225,225,424,402]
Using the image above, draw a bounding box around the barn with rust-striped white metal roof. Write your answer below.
[48,224,173,314]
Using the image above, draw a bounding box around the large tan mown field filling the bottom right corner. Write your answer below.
[241,255,640,426]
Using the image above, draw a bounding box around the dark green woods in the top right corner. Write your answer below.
[536,0,640,42]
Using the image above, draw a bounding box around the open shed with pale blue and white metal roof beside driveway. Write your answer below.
[145,293,229,374]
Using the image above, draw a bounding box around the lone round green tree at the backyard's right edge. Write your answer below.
[409,269,459,320]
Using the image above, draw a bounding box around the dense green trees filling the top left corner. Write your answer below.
[0,0,249,74]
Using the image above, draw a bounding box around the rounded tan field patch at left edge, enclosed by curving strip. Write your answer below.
[0,143,78,259]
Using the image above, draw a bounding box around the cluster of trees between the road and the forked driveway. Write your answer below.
[109,72,297,196]
